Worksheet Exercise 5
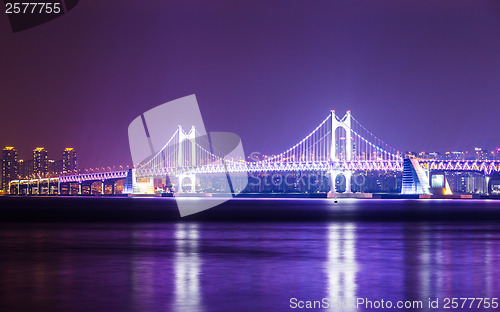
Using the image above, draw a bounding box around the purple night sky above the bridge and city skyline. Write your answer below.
[0,0,500,168]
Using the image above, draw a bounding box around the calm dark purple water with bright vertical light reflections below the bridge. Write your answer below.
[0,199,500,312]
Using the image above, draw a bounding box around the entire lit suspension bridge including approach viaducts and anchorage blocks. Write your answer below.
[7,110,500,194]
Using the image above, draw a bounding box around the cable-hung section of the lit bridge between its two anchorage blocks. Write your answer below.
[135,111,403,192]
